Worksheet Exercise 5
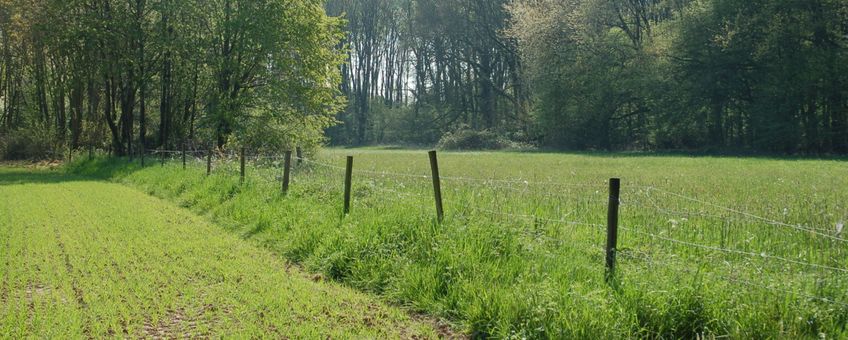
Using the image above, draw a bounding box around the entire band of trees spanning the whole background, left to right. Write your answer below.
[0,0,848,154]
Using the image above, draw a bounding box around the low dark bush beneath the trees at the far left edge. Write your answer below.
[0,128,61,160]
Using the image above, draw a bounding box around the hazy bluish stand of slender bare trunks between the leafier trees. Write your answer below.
[325,0,529,145]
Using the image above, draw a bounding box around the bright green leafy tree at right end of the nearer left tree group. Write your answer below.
[209,0,343,145]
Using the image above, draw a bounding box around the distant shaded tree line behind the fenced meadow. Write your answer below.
[326,0,848,154]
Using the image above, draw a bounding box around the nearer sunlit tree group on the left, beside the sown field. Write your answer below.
[0,0,343,159]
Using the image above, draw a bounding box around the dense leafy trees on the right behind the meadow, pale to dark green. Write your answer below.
[508,0,848,153]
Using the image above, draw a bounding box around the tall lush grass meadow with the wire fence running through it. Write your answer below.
[69,150,848,338]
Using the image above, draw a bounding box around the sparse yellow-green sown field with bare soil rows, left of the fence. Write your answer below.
[0,168,448,339]
